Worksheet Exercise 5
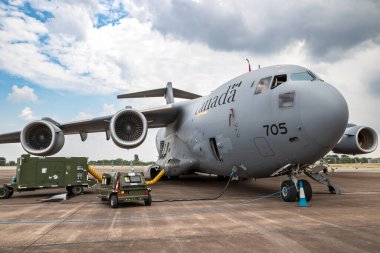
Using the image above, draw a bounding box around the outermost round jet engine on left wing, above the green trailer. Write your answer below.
[20,120,65,156]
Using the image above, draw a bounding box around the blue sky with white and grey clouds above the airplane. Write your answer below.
[0,0,380,160]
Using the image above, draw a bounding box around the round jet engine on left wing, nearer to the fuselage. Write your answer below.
[110,108,148,149]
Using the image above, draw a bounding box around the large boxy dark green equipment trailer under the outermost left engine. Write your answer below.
[0,155,96,199]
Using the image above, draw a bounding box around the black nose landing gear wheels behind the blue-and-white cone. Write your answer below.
[280,176,313,202]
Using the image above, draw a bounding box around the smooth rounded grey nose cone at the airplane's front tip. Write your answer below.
[300,82,348,148]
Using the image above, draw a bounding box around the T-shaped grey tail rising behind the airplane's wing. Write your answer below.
[117,82,201,104]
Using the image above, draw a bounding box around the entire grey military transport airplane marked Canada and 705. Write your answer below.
[0,65,378,202]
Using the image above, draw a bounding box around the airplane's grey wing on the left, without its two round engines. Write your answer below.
[0,104,179,143]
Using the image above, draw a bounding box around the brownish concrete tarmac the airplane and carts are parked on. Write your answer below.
[0,168,380,252]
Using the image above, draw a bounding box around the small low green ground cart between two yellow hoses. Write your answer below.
[98,169,152,208]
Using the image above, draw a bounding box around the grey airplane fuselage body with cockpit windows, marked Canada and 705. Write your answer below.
[156,65,348,178]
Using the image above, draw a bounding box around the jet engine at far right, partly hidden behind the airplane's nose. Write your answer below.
[333,125,378,155]
